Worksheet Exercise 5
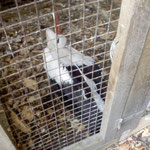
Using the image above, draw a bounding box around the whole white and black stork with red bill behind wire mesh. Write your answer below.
[43,4,104,134]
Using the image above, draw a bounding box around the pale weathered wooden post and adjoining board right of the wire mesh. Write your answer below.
[101,0,150,142]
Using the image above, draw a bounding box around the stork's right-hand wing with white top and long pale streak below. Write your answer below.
[53,47,104,111]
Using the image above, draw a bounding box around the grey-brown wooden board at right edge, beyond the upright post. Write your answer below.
[117,27,150,141]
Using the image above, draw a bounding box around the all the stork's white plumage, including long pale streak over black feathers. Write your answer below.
[45,29,104,112]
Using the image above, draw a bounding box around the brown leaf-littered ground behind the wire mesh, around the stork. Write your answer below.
[0,0,120,149]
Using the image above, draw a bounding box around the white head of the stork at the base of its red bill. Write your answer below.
[46,29,67,50]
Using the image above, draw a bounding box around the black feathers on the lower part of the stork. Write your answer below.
[42,63,102,135]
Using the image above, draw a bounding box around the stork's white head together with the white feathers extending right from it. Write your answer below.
[46,29,94,66]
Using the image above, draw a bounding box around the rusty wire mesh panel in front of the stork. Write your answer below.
[0,0,120,150]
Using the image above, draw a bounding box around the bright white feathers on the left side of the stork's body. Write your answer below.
[43,48,73,85]
